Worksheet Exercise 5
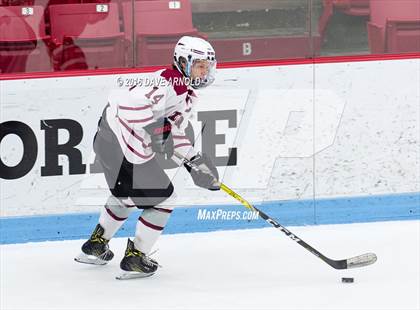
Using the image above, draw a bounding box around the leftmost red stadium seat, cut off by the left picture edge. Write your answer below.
[0,6,52,73]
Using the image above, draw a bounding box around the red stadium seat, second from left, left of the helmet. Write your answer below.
[49,3,125,70]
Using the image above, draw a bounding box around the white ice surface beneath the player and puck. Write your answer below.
[0,221,420,310]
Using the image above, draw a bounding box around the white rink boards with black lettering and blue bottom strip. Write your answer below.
[0,58,420,243]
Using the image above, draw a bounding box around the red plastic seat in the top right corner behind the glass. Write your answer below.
[367,0,420,54]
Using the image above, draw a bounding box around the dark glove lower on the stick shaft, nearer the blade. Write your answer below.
[184,153,220,191]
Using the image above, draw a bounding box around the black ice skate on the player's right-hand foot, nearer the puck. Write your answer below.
[116,239,159,280]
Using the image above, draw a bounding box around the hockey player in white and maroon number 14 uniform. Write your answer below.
[75,36,220,277]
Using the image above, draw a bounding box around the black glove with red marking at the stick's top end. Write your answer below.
[144,118,174,159]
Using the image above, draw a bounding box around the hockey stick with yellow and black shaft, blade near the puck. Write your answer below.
[174,151,377,269]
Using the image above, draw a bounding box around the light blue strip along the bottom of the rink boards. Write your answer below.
[0,193,420,244]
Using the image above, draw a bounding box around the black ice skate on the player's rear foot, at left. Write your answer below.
[74,224,114,265]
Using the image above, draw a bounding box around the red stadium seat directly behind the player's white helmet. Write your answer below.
[123,0,204,66]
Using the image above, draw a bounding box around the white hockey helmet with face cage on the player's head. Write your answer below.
[174,36,217,88]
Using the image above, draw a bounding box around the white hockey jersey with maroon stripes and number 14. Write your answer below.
[107,69,197,164]
